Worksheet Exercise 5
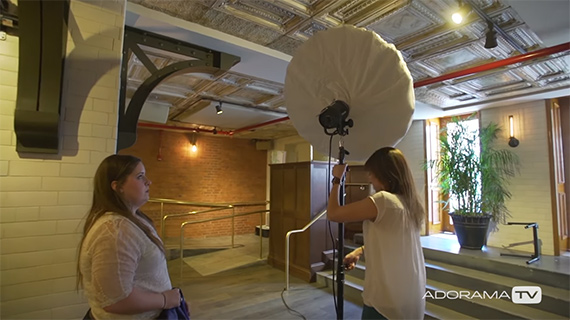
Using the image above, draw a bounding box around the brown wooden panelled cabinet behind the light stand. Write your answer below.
[267,161,338,281]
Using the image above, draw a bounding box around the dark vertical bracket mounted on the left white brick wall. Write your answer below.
[14,0,69,154]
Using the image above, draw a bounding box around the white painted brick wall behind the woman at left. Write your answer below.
[0,0,126,319]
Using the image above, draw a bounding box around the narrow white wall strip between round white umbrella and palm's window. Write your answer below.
[396,120,426,234]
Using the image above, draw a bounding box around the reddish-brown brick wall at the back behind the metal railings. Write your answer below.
[119,129,267,239]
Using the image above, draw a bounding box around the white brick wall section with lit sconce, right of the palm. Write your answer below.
[481,100,554,255]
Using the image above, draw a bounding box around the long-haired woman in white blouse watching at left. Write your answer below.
[78,155,180,319]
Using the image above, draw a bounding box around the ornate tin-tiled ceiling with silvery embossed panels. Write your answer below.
[128,0,570,139]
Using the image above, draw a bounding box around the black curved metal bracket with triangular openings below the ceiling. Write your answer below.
[117,26,240,150]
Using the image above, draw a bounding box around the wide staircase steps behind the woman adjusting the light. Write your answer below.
[317,241,570,319]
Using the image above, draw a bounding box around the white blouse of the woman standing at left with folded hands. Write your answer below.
[79,212,172,319]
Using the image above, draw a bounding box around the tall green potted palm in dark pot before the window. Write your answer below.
[426,116,520,250]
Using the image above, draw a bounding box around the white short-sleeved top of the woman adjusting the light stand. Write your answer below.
[362,191,426,319]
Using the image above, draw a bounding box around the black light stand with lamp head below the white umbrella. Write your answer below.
[319,100,353,320]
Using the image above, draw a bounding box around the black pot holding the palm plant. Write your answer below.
[450,213,491,250]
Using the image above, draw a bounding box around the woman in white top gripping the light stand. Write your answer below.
[327,147,426,319]
